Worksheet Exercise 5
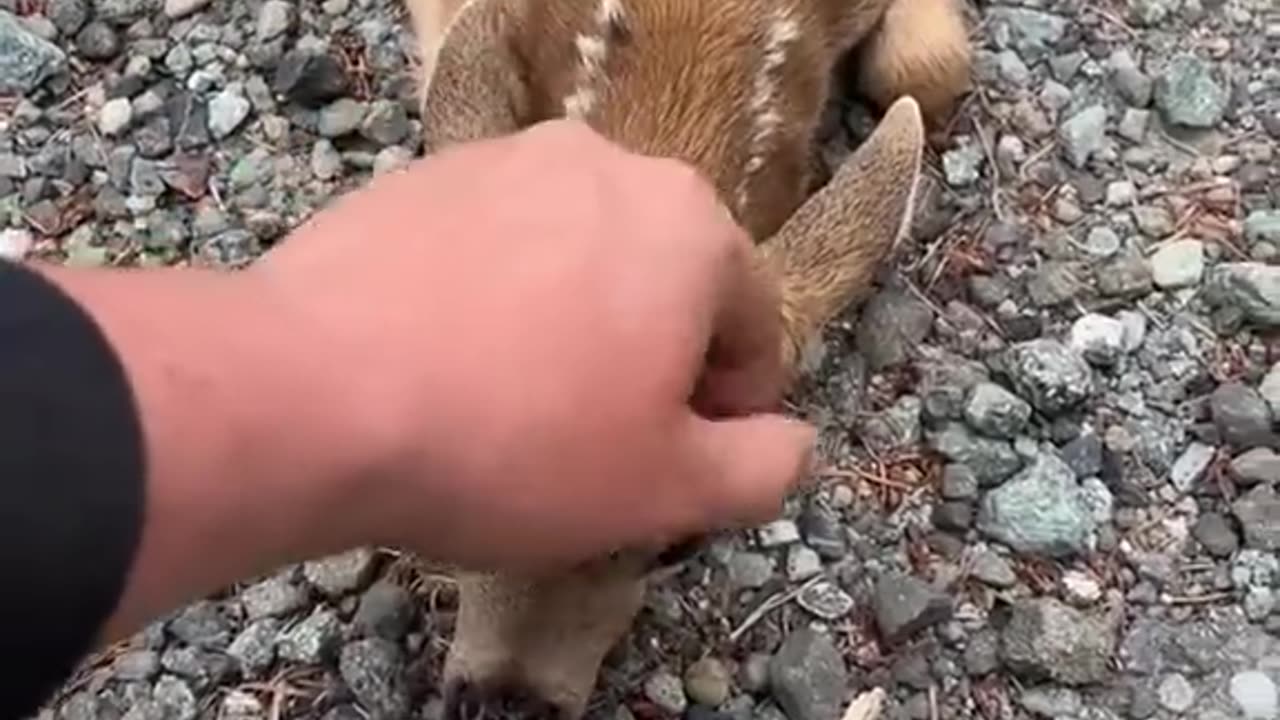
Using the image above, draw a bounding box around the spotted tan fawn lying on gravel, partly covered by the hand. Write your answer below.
[394,0,969,720]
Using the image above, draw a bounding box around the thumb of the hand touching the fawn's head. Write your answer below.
[694,414,817,527]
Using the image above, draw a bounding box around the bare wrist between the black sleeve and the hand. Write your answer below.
[32,262,376,637]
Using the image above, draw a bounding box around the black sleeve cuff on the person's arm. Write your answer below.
[0,261,145,719]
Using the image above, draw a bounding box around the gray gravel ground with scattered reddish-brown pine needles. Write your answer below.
[0,0,1280,720]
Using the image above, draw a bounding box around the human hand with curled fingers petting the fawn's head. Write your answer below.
[247,122,813,569]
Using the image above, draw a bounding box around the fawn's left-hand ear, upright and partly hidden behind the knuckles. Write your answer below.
[408,0,529,154]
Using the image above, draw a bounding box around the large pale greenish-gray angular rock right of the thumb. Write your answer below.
[977,452,1096,557]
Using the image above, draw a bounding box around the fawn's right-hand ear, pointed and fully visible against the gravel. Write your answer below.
[758,96,925,369]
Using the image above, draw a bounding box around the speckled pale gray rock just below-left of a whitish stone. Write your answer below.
[1006,338,1093,415]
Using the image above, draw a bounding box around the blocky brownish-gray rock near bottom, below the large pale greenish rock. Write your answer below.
[1001,597,1120,685]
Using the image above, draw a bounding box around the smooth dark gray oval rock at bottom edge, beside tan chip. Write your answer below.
[769,628,849,720]
